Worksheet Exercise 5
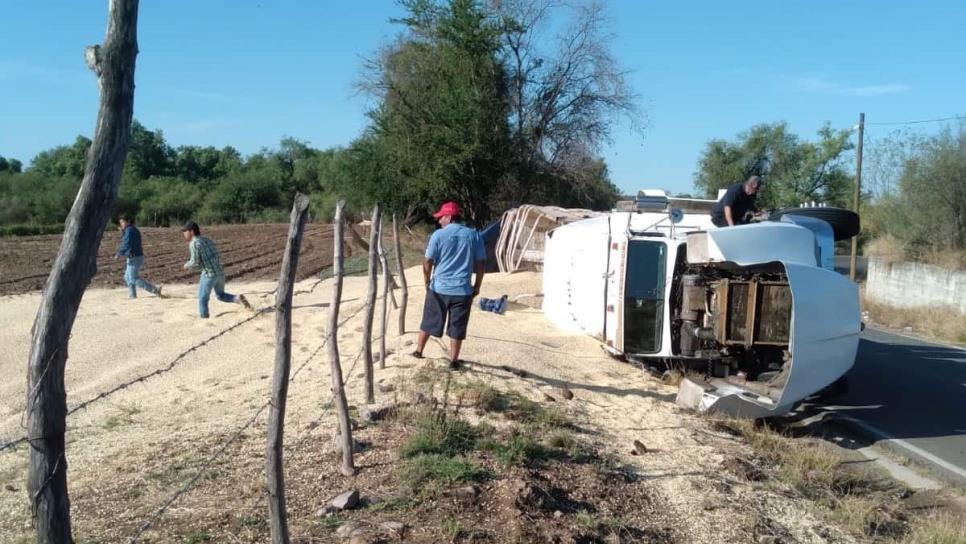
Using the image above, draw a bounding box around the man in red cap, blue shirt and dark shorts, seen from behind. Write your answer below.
[413,202,486,368]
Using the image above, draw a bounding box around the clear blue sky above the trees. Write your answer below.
[0,0,966,196]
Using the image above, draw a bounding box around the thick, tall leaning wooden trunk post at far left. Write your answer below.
[27,0,138,543]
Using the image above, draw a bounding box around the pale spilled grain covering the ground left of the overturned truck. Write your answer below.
[0,268,948,542]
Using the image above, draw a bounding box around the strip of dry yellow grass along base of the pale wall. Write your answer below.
[861,291,966,344]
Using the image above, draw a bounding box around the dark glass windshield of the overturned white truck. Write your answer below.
[624,240,667,354]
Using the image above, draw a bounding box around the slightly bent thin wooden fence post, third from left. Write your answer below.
[325,200,356,476]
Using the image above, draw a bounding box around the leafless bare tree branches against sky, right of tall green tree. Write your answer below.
[494,0,644,168]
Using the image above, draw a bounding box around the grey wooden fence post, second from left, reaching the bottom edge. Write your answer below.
[265,193,309,544]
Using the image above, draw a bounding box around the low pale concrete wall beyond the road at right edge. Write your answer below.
[865,258,966,314]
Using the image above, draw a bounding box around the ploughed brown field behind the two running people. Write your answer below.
[0,224,351,295]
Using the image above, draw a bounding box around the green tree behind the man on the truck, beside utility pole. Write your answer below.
[694,122,853,207]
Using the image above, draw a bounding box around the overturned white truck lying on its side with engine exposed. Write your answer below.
[543,191,862,418]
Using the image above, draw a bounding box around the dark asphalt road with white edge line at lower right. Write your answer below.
[826,329,966,483]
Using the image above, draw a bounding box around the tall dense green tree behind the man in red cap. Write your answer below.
[362,0,509,222]
